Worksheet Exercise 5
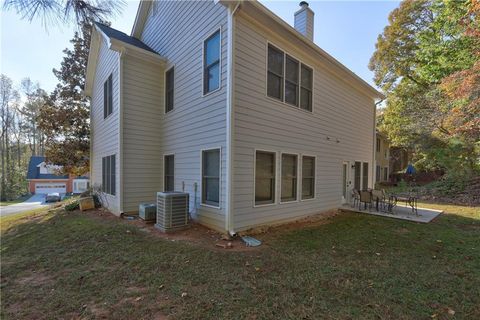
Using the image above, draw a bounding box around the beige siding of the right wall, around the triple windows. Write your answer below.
[233,13,374,230]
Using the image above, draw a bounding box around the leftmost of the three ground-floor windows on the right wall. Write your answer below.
[255,151,276,205]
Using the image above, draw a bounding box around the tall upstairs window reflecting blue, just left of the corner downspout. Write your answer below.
[203,30,220,94]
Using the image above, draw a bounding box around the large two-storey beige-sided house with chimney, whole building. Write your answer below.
[85,1,383,233]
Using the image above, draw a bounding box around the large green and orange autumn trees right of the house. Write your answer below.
[369,0,480,180]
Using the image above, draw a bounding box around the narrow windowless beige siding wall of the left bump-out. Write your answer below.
[122,55,164,212]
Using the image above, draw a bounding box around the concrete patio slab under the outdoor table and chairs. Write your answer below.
[341,205,443,223]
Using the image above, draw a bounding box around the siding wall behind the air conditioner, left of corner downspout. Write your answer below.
[139,1,227,230]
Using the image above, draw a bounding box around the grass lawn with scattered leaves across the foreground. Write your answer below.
[1,204,480,319]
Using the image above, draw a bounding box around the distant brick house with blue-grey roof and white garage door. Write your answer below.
[27,156,89,194]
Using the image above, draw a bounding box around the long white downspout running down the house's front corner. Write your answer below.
[225,3,240,236]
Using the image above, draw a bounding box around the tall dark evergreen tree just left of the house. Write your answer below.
[39,23,92,175]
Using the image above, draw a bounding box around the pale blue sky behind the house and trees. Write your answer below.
[0,0,399,91]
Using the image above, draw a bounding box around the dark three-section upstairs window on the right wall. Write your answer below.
[267,45,313,111]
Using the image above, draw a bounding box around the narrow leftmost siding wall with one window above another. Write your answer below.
[90,39,120,215]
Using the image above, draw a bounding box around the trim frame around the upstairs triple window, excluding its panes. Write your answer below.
[265,40,316,114]
